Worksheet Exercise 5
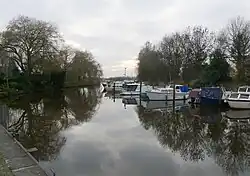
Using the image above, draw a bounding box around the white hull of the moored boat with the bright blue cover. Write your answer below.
[146,92,188,101]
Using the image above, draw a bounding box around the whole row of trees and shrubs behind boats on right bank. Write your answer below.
[138,17,250,87]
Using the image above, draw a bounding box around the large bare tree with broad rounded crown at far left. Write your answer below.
[1,16,62,75]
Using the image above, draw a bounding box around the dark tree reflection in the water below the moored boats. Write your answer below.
[137,104,250,175]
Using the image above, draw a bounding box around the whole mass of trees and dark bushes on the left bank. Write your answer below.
[0,16,102,93]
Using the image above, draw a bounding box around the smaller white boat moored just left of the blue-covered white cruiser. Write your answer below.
[120,83,152,96]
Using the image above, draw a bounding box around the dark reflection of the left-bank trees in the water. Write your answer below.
[3,88,100,161]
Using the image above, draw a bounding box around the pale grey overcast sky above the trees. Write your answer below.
[0,0,250,76]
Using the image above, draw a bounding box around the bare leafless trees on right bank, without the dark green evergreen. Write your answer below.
[138,17,250,85]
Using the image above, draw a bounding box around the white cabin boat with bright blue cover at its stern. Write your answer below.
[146,85,189,101]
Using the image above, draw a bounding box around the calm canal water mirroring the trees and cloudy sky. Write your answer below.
[0,88,250,176]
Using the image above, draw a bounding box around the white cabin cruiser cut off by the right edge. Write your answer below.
[227,86,250,109]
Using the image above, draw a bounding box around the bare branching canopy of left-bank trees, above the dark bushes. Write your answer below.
[0,16,102,84]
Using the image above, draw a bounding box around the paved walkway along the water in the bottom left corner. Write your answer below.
[0,125,48,176]
